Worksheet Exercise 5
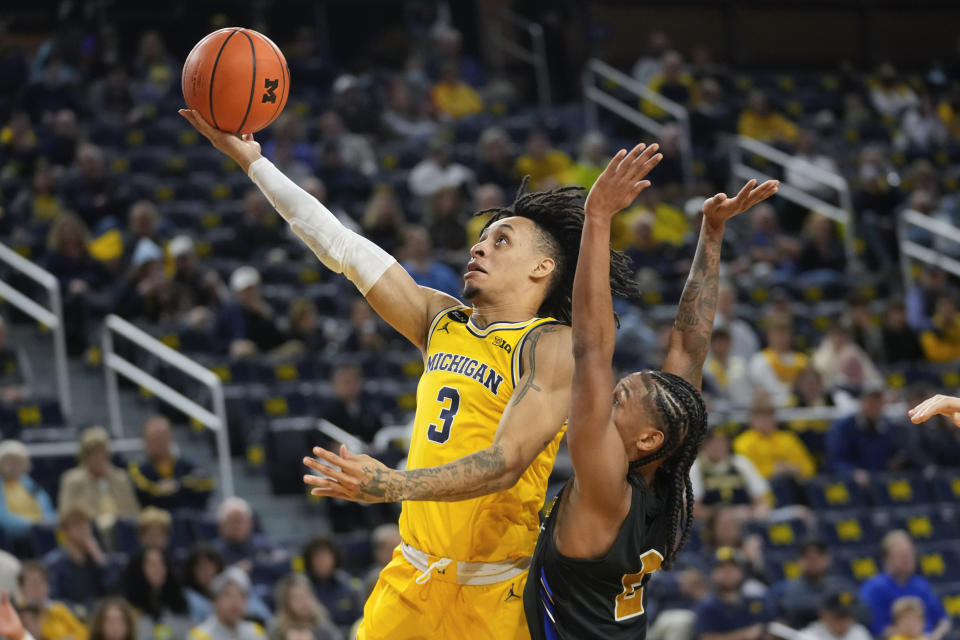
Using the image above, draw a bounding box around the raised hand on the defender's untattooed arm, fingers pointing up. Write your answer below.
[583,142,663,218]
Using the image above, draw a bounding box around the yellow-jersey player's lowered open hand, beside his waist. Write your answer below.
[303,445,402,502]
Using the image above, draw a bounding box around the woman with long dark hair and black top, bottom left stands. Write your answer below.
[120,547,190,638]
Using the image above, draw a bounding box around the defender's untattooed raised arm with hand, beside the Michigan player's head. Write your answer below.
[567,144,662,522]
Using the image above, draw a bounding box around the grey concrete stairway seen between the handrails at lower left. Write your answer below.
[9,323,329,547]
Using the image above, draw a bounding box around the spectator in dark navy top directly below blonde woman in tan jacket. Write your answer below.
[43,503,114,606]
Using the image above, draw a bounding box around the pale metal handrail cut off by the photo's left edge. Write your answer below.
[0,243,73,419]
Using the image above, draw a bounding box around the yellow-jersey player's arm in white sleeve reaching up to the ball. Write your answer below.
[180,109,458,350]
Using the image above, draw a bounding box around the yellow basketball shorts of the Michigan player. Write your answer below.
[357,547,530,640]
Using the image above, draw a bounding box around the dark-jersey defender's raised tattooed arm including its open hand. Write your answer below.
[663,180,780,389]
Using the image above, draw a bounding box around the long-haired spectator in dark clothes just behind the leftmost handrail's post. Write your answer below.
[40,213,103,355]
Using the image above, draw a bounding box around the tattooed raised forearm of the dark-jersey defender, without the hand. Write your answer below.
[673,229,722,383]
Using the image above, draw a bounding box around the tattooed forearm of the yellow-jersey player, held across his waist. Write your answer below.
[361,444,507,502]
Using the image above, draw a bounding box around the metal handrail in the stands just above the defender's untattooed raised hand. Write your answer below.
[583,58,695,190]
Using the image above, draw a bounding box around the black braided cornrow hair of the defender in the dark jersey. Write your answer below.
[630,371,707,569]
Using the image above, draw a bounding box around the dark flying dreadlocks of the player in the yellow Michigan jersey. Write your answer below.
[475,176,640,324]
